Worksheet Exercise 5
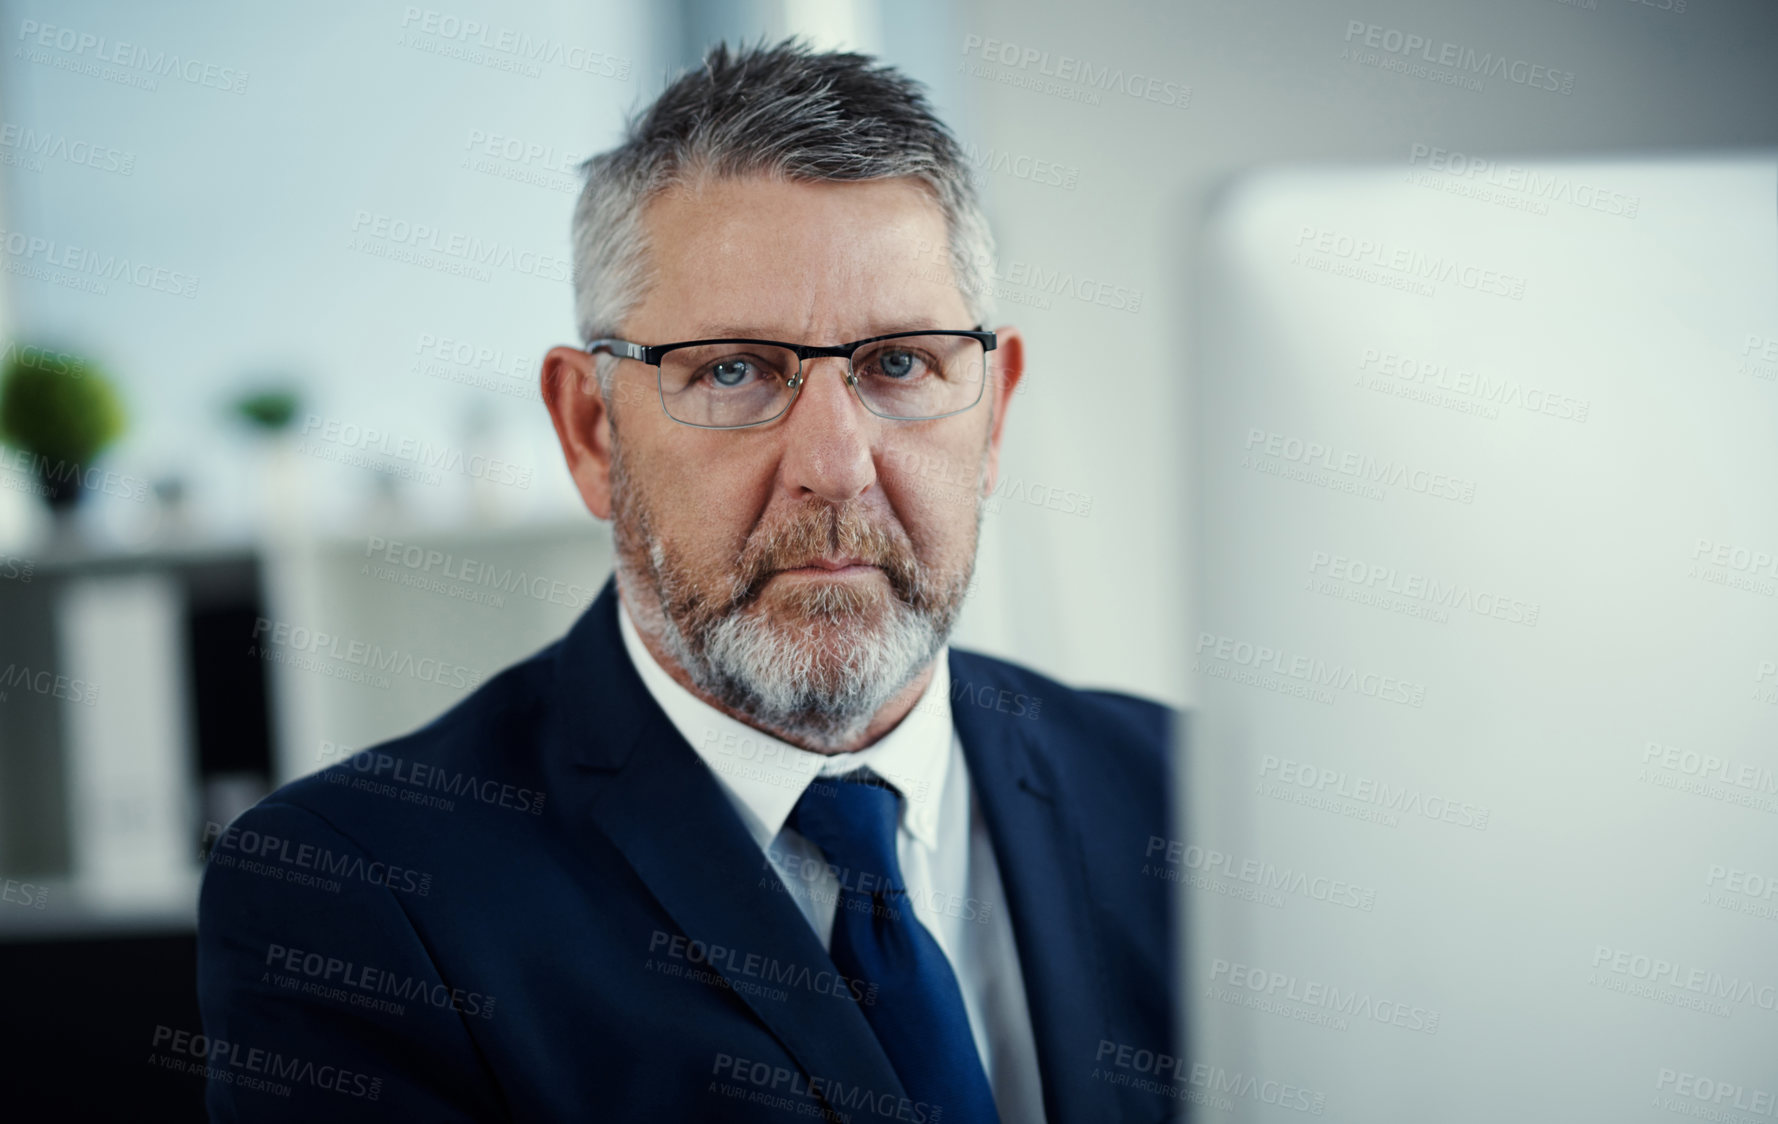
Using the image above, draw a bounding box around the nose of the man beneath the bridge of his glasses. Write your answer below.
[781,357,877,503]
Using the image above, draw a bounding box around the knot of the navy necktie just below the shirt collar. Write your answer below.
[789,768,907,896]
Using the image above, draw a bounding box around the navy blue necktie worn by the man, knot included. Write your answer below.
[789,768,999,1124]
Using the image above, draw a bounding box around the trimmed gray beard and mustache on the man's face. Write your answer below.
[612,433,985,752]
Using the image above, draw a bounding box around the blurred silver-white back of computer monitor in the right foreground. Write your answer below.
[1180,153,1778,1124]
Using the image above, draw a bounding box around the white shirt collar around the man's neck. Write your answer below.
[617,598,955,850]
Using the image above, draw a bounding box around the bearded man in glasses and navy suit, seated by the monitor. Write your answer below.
[199,43,1184,1124]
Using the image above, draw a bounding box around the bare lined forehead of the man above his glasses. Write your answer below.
[631,176,973,343]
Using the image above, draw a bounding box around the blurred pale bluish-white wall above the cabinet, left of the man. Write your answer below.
[0,0,665,537]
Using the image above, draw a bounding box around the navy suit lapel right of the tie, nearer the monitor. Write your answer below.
[951,649,1109,1124]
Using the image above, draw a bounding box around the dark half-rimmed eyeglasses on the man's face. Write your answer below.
[587,327,996,429]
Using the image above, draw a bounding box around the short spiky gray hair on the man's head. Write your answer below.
[574,39,994,373]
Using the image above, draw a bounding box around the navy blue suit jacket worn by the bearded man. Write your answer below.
[194,582,1179,1124]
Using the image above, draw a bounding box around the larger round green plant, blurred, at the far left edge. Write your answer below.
[0,347,126,473]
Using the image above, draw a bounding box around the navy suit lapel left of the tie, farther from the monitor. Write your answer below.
[557,582,905,1097]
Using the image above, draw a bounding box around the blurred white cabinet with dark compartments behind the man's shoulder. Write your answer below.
[0,516,610,939]
